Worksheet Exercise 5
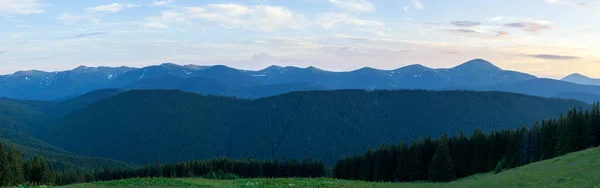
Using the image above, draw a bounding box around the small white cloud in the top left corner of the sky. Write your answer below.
[0,0,44,15]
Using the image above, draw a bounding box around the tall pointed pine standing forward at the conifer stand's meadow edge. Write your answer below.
[429,134,456,182]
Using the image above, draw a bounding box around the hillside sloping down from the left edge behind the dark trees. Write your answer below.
[0,128,135,169]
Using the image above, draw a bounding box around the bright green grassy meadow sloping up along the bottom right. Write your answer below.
[56,149,600,188]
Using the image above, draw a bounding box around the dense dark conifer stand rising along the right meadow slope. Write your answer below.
[333,103,600,182]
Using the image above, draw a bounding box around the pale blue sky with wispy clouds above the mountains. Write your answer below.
[0,0,600,78]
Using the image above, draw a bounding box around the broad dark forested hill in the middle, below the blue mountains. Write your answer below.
[46,90,588,164]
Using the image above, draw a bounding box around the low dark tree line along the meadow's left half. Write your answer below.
[0,143,327,187]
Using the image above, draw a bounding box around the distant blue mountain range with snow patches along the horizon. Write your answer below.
[0,59,600,102]
